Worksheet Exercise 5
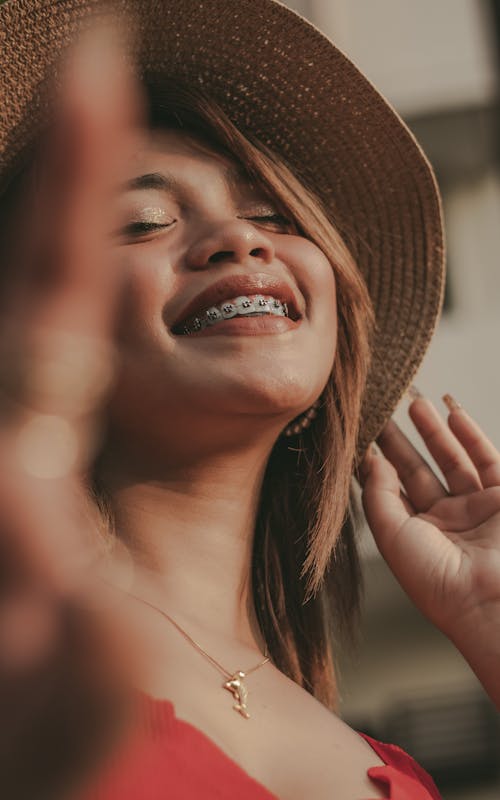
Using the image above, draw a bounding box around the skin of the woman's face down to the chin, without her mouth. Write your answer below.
[108,132,336,450]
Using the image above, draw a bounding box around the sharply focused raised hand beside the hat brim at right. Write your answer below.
[361,396,500,708]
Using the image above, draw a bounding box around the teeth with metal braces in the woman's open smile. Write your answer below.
[172,294,299,336]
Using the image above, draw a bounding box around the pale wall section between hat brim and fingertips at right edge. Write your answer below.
[398,171,500,447]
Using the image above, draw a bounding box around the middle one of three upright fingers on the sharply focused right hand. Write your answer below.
[409,395,482,495]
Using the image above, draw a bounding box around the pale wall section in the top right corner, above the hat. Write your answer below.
[308,0,495,115]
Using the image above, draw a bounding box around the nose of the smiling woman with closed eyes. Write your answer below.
[187,220,274,269]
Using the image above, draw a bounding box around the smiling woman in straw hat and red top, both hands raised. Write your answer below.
[1,0,500,800]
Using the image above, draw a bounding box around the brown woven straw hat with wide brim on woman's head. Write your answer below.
[0,0,444,453]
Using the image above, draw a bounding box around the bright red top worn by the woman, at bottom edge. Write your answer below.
[82,696,442,800]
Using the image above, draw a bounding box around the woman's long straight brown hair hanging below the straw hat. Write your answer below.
[146,76,373,709]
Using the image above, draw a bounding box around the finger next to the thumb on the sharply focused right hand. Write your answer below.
[377,420,447,511]
